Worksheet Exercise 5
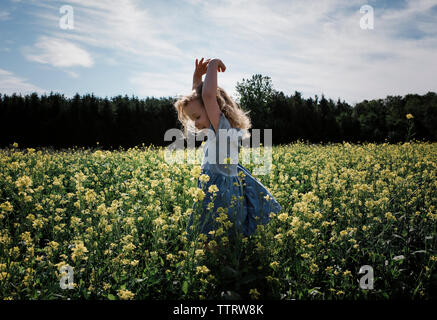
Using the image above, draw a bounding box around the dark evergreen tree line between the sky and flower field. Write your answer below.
[0,74,437,149]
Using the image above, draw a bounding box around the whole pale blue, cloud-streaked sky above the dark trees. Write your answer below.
[0,0,437,105]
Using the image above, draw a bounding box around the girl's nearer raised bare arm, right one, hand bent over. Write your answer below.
[202,59,226,134]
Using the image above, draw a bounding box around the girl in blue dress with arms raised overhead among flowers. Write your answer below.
[175,58,281,239]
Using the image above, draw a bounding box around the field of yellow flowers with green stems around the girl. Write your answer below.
[0,141,437,300]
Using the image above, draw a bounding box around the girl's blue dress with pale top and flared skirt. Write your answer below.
[187,112,282,239]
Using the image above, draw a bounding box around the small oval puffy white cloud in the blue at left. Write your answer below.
[24,36,94,67]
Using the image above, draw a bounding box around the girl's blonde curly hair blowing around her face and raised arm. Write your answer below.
[174,82,252,139]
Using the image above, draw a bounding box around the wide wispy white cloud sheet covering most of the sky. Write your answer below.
[11,0,437,103]
